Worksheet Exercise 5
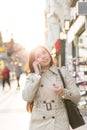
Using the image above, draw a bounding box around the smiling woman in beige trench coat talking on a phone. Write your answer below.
[22,46,80,130]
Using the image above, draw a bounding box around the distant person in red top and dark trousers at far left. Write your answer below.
[2,66,11,90]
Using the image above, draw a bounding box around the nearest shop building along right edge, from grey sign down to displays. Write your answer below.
[65,0,87,108]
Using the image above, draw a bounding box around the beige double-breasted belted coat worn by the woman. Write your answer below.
[22,66,80,130]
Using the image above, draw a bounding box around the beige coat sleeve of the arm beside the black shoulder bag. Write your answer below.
[61,67,81,103]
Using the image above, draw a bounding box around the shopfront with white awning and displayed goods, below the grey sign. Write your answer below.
[66,16,87,108]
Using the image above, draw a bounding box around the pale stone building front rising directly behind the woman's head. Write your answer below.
[45,0,70,49]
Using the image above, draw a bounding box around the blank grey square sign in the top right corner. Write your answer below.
[78,1,87,15]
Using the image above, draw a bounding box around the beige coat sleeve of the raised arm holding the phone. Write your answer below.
[22,73,41,102]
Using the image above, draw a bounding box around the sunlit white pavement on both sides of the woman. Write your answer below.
[0,75,87,130]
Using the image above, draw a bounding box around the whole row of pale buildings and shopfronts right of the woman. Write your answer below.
[45,0,87,108]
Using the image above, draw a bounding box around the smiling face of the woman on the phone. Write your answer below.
[34,48,51,68]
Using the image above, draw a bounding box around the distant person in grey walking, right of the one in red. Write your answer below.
[15,64,22,88]
